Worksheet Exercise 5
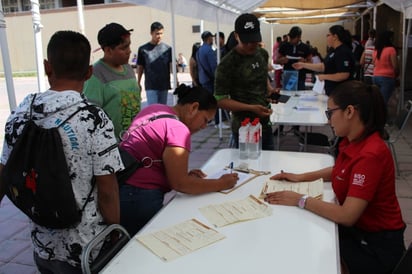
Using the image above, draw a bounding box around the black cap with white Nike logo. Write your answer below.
[235,13,262,43]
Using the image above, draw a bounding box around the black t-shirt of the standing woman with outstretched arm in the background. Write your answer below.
[324,44,355,95]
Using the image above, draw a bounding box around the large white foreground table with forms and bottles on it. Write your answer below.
[103,149,340,274]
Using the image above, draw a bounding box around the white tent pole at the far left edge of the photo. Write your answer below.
[0,1,16,110]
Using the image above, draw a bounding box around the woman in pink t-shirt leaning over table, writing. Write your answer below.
[120,85,238,235]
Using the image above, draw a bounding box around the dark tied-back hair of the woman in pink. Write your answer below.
[173,84,217,110]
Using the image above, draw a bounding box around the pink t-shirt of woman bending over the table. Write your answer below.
[120,104,191,192]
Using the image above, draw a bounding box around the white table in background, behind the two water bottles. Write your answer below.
[270,90,328,150]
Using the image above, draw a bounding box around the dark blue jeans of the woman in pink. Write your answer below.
[120,184,164,237]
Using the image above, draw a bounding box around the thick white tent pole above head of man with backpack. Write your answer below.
[30,0,46,92]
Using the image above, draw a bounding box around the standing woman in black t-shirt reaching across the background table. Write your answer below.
[292,25,355,95]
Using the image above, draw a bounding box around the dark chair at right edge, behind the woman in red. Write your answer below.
[385,100,412,176]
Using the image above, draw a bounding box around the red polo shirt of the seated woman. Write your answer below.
[332,133,405,232]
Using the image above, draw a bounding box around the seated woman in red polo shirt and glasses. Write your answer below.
[265,81,405,274]
